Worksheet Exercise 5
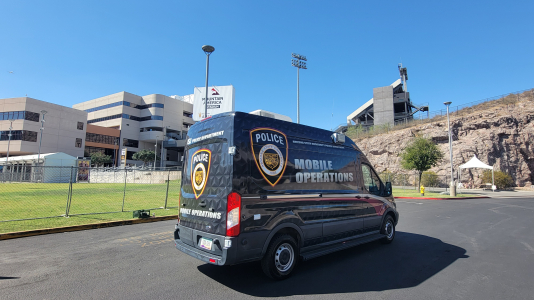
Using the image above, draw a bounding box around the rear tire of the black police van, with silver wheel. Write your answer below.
[261,234,300,280]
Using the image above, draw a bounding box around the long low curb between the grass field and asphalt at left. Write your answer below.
[0,215,178,241]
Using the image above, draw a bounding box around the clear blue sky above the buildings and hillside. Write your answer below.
[0,0,534,129]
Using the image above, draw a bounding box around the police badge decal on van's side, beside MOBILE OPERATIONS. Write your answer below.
[250,127,288,187]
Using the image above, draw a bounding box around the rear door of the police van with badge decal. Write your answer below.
[179,117,233,241]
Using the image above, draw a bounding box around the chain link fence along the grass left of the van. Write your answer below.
[0,165,181,233]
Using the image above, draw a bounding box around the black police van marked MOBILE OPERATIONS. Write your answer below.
[174,112,399,279]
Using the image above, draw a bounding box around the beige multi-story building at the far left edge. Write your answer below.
[0,97,87,161]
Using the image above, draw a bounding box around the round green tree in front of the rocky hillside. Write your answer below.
[400,137,443,186]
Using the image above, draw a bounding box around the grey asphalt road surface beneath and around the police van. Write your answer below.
[0,197,534,300]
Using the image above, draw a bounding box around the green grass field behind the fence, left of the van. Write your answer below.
[0,180,180,233]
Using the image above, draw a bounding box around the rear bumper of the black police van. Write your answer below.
[174,225,237,266]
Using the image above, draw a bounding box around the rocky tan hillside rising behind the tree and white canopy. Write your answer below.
[347,91,534,187]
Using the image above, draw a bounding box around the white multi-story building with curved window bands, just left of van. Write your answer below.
[73,92,195,166]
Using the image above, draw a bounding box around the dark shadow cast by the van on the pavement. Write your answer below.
[198,231,469,297]
